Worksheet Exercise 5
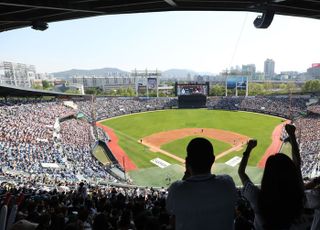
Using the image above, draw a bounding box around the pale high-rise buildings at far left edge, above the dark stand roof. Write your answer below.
[0,61,36,88]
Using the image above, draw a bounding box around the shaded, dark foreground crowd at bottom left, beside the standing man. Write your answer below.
[0,183,171,230]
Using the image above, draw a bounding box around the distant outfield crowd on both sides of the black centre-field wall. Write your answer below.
[77,96,309,120]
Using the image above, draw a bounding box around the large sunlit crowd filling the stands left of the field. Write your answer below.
[0,101,115,187]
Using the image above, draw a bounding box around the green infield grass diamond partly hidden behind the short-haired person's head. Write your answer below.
[161,136,232,159]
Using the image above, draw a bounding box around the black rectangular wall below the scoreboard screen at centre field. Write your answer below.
[178,94,207,109]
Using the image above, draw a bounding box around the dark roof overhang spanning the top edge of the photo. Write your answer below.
[0,0,320,32]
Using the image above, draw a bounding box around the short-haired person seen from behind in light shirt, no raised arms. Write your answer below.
[166,138,237,230]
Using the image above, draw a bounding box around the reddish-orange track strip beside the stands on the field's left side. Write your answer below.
[96,123,137,171]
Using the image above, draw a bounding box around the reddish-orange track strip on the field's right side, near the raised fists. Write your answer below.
[257,120,290,168]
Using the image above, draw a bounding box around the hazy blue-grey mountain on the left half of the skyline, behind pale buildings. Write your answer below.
[52,68,129,80]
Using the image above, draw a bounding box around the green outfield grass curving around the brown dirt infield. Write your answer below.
[102,109,282,168]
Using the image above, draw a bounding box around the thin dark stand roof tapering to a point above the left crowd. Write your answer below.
[0,84,88,97]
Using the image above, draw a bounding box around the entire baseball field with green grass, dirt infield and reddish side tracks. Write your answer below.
[98,109,284,186]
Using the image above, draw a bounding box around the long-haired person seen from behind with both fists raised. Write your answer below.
[238,124,304,230]
